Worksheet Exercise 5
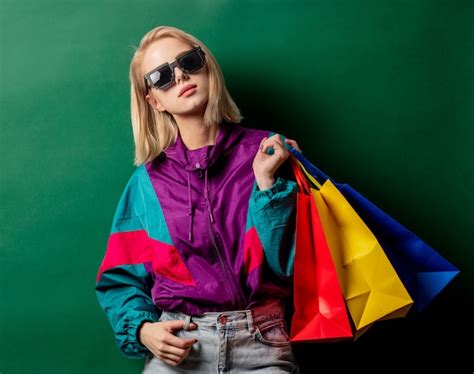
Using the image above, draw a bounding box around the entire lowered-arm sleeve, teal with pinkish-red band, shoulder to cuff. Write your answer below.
[95,170,161,359]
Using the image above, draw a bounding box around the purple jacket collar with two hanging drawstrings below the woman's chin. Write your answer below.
[159,120,244,242]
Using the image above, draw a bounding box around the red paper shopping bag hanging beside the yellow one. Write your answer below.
[290,159,352,342]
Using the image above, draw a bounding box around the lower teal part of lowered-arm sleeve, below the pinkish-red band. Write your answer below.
[95,264,161,359]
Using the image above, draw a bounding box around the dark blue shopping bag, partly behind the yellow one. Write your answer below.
[290,148,459,312]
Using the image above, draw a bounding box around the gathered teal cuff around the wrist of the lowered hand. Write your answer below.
[116,311,159,359]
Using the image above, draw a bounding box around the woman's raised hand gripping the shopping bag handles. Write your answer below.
[252,134,301,190]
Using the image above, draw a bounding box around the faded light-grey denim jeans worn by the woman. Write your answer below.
[142,300,299,374]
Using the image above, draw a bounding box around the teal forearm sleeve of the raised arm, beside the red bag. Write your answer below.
[249,177,298,279]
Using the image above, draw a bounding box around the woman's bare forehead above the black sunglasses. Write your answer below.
[143,37,192,72]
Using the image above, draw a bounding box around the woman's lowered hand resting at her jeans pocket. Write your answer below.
[139,320,197,366]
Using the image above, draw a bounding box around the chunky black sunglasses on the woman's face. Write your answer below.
[144,46,206,90]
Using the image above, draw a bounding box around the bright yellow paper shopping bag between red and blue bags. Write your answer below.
[298,161,413,337]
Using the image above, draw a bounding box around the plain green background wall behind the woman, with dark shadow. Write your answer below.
[0,0,474,374]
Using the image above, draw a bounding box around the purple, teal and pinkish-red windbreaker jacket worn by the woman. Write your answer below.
[95,121,298,358]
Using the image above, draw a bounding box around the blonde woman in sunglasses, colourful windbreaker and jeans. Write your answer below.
[95,26,299,373]
